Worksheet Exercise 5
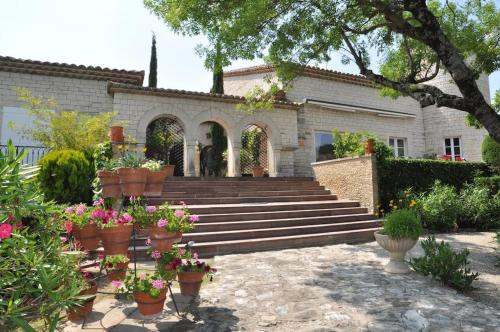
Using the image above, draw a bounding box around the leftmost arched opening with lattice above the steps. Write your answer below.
[146,116,184,176]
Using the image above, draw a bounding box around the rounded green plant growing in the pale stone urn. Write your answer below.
[383,209,422,240]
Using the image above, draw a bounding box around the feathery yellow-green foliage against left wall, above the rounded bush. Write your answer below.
[14,88,116,154]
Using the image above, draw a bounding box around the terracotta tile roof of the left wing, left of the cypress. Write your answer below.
[0,56,144,85]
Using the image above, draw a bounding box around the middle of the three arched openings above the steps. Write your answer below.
[198,121,229,176]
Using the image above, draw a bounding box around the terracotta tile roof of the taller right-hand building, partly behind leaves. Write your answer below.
[224,65,374,87]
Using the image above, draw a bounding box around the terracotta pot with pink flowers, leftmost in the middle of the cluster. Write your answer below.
[64,204,100,250]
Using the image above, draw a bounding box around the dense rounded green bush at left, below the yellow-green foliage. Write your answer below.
[38,150,94,204]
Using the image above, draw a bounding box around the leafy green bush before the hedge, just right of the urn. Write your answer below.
[417,181,462,231]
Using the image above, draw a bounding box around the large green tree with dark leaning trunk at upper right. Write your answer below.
[144,0,500,142]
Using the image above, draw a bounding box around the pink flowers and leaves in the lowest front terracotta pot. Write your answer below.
[112,273,168,298]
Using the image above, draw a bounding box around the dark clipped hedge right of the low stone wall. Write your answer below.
[377,158,491,206]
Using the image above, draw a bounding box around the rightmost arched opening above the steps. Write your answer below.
[240,124,270,176]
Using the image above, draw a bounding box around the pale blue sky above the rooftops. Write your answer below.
[0,0,500,100]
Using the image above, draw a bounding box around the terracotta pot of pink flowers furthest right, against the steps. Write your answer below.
[149,204,199,252]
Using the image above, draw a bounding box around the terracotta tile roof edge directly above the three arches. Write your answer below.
[108,82,302,109]
